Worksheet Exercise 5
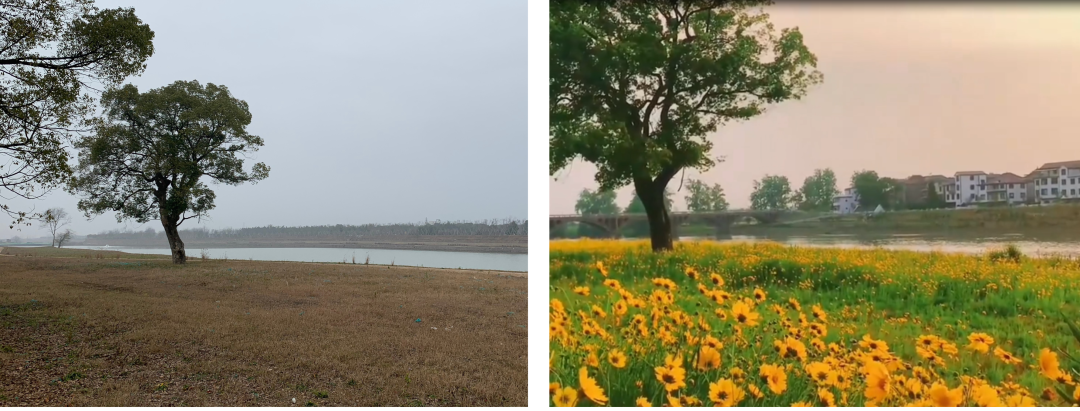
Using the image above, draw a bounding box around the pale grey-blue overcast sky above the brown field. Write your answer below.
[0,0,528,238]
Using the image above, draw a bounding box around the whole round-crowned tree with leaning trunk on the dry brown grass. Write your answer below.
[69,81,270,264]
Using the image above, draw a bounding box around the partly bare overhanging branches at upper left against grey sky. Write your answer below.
[0,0,153,227]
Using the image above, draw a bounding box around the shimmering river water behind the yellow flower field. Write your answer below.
[679,233,1080,257]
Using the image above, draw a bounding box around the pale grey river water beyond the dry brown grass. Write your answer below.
[71,246,529,272]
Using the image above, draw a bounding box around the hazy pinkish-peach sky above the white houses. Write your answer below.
[550,3,1080,214]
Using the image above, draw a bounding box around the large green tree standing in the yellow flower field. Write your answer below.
[549,1,822,250]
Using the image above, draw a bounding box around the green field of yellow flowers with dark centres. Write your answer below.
[549,241,1080,407]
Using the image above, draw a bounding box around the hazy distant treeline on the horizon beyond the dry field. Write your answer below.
[86,219,529,242]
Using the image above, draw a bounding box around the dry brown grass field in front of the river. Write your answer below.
[0,248,528,407]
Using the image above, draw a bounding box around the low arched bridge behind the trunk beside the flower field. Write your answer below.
[548,210,794,236]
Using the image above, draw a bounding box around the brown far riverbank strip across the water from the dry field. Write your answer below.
[73,235,529,254]
